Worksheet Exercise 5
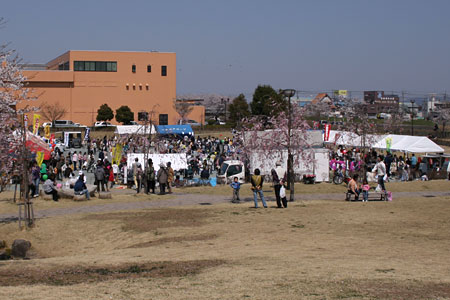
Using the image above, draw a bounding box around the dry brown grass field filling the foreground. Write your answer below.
[0,181,450,299]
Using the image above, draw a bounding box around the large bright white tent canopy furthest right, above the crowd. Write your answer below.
[372,134,444,153]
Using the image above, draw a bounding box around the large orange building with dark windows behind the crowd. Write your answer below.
[18,51,205,126]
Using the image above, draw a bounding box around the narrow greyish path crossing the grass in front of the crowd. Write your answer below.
[0,191,450,223]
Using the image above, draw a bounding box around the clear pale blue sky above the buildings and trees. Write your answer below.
[0,0,450,95]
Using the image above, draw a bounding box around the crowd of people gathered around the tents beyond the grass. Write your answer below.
[14,132,450,207]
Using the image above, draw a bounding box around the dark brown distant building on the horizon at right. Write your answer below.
[364,91,400,116]
